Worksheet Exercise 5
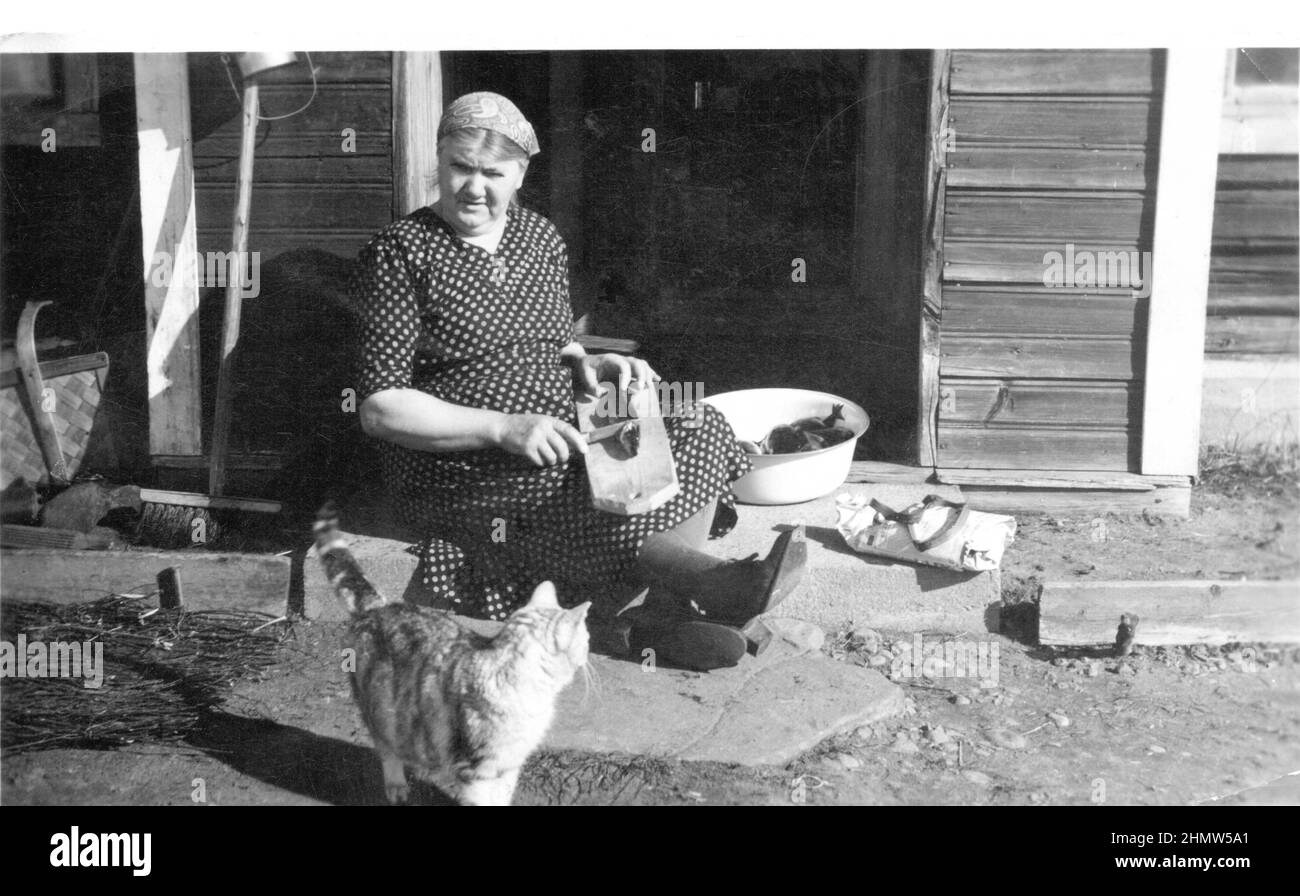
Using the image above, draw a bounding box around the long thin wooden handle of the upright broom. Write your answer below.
[208,81,257,495]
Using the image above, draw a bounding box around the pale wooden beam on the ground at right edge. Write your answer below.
[1039,580,1300,646]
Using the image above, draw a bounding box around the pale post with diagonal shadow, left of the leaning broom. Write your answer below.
[135,53,203,456]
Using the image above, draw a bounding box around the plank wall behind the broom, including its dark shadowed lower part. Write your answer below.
[178,52,394,460]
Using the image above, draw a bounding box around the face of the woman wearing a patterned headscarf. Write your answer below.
[438,142,525,237]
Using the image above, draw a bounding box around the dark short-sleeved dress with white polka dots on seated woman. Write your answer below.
[354,205,750,619]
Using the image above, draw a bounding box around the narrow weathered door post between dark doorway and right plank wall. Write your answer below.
[917,49,952,467]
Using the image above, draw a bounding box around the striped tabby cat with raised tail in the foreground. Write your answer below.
[316,508,590,805]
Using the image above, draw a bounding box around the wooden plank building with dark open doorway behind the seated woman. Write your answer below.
[5,49,1300,514]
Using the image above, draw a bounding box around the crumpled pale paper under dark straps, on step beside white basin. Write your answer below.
[836,492,1015,572]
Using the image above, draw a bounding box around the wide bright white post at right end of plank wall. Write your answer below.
[1141,48,1225,476]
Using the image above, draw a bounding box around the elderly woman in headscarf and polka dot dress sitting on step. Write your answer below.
[354,94,806,670]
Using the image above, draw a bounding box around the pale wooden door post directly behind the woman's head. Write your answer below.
[393,53,442,217]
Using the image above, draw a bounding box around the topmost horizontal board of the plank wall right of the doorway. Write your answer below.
[953,49,1160,94]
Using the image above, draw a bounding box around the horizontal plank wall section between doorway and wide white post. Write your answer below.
[937,49,1164,471]
